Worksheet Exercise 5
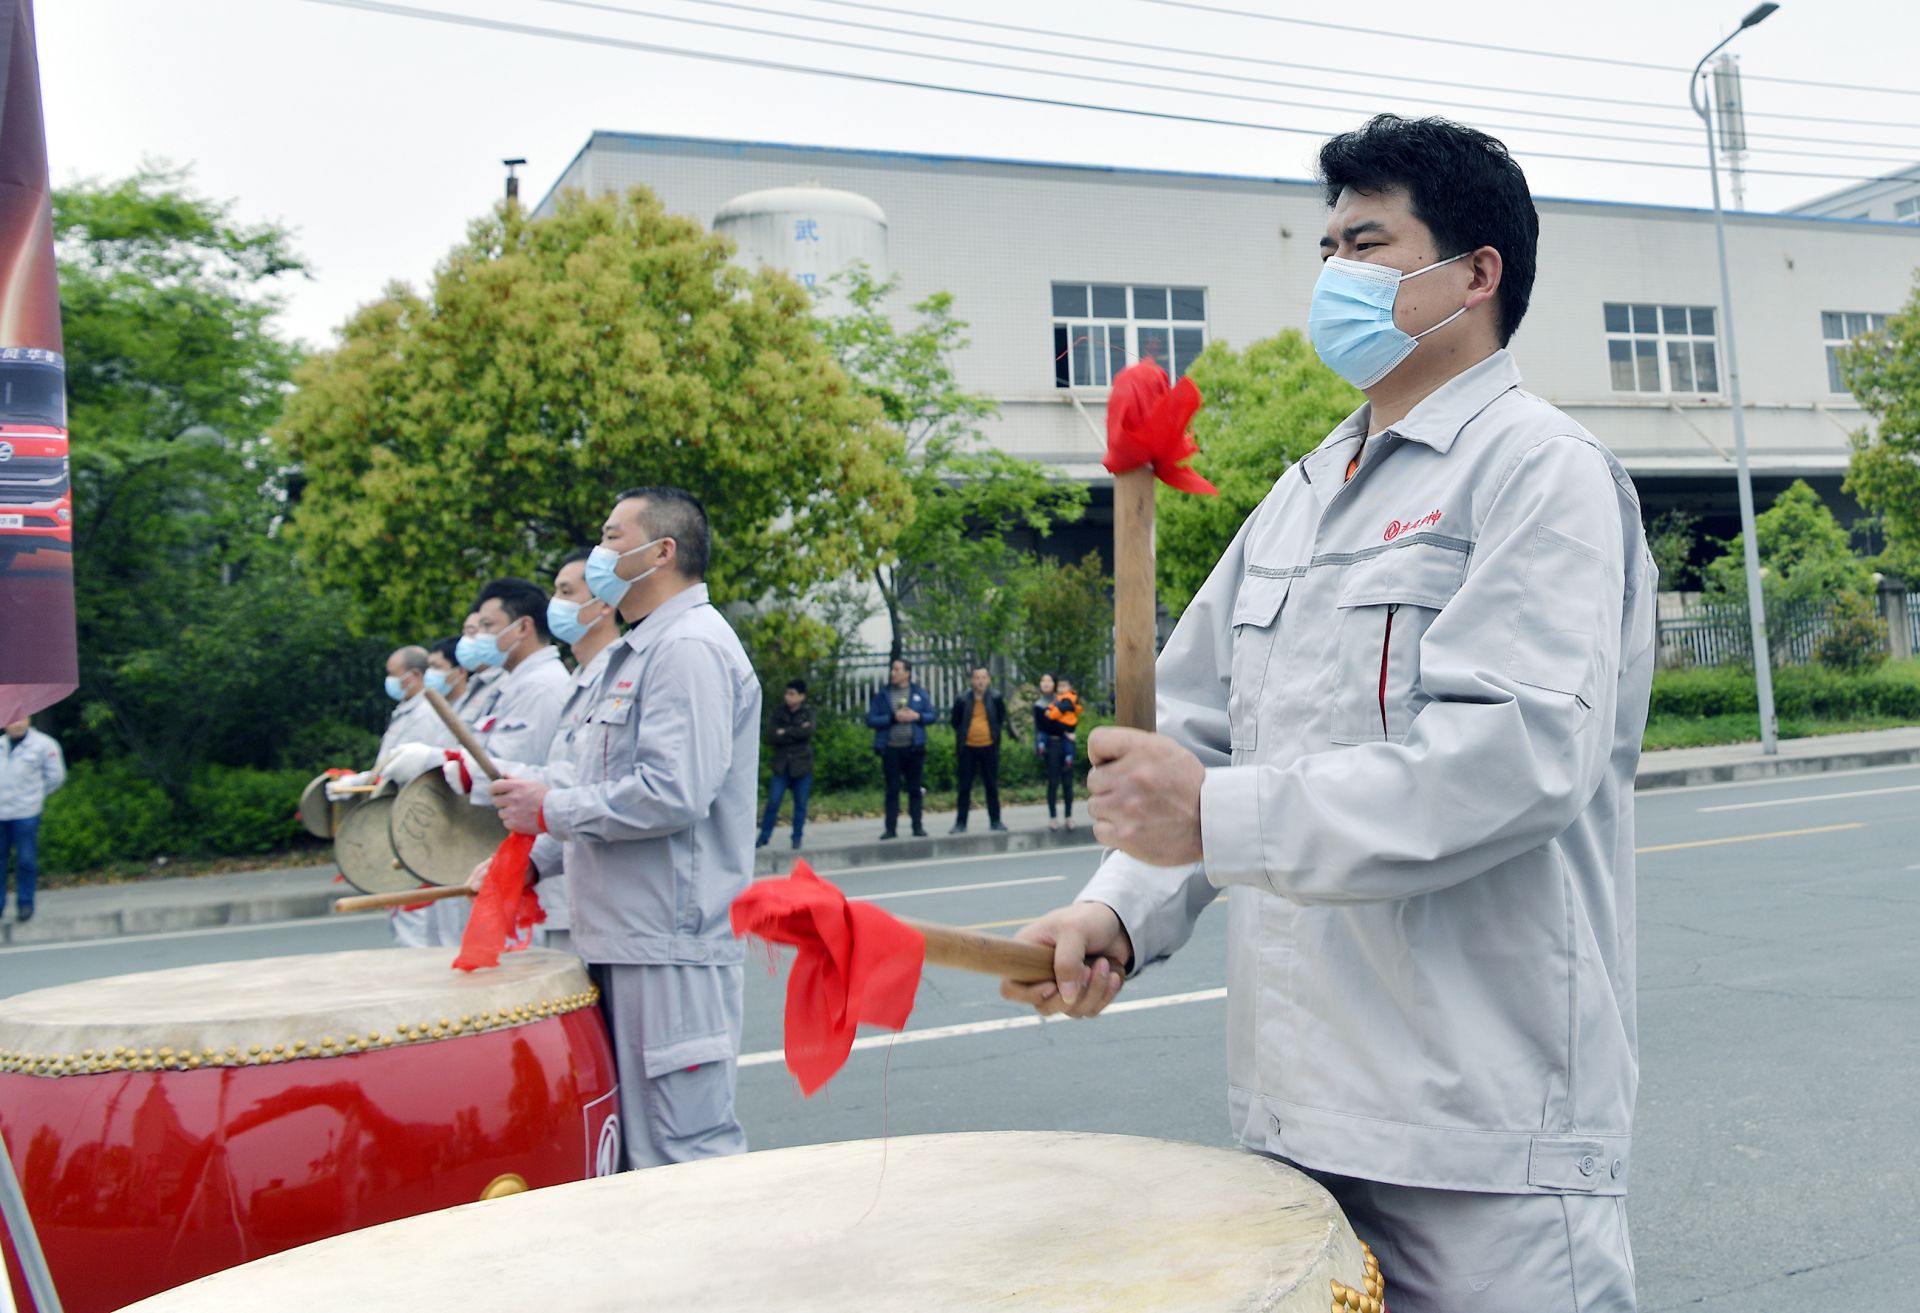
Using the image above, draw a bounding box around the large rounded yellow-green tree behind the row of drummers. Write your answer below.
[276,188,912,633]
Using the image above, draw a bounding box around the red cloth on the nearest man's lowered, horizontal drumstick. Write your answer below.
[732,862,927,1094]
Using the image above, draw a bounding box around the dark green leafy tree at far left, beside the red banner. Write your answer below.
[54,167,384,802]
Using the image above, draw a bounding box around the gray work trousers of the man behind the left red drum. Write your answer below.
[588,962,747,1171]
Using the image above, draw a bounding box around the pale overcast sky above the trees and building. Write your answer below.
[36,0,1920,346]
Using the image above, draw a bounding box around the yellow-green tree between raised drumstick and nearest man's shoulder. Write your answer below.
[1154,328,1365,616]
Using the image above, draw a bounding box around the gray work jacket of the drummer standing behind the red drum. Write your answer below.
[545,584,760,966]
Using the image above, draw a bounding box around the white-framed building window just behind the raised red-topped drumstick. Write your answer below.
[1054,282,1206,388]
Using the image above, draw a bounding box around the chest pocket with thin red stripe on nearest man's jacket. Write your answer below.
[1329,545,1467,743]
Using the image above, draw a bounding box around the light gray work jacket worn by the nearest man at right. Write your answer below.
[1081,351,1655,1194]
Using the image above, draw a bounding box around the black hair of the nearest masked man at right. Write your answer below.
[1319,113,1540,346]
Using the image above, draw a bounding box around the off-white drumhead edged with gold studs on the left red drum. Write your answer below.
[0,948,595,1075]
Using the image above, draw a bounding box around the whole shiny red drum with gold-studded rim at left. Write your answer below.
[0,948,618,1313]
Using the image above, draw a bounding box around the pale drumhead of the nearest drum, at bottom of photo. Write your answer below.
[116,1133,1379,1313]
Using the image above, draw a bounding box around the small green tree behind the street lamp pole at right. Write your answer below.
[1701,478,1872,664]
